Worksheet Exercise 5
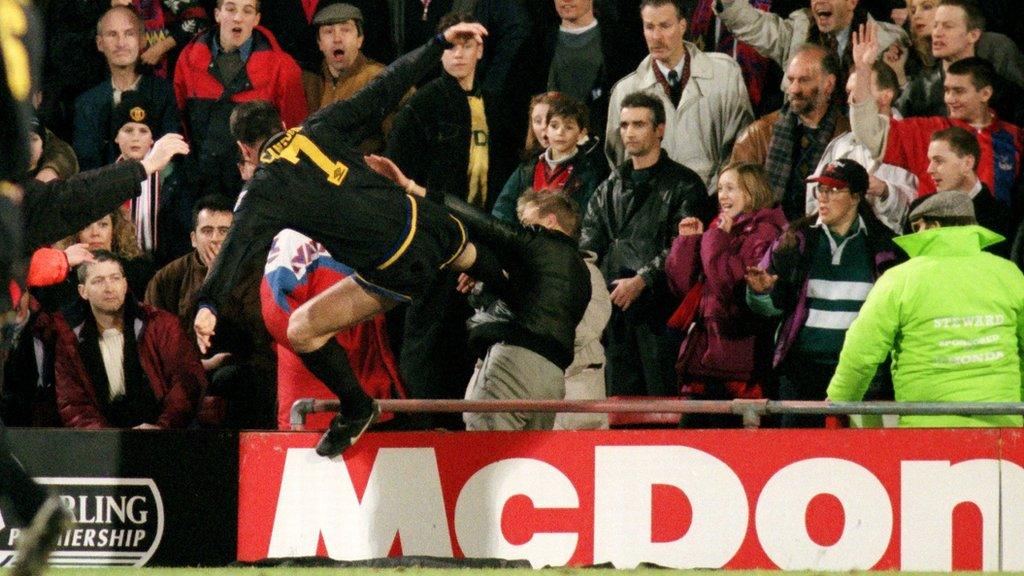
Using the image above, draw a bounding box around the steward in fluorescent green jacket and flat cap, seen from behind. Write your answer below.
[828,191,1024,427]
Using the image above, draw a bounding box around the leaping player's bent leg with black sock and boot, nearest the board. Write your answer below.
[288,277,395,457]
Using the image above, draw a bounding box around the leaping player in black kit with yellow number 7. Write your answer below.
[195,23,500,456]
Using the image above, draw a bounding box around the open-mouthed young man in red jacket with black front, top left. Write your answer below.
[174,0,306,198]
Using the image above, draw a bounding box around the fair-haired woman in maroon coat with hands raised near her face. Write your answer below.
[665,163,786,427]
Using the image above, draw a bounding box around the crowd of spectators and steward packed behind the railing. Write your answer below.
[8,0,1024,429]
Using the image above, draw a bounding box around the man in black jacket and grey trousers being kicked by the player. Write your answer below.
[456,194,591,430]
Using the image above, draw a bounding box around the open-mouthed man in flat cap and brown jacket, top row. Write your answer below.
[302,3,412,154]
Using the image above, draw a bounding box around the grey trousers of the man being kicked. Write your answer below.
[462,342,565,430]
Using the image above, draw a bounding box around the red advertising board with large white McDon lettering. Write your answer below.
[239,429,1024,571]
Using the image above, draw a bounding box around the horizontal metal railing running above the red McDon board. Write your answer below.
[290,398,1024,430]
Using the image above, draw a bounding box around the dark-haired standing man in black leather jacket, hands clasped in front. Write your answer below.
[580,92,714,396]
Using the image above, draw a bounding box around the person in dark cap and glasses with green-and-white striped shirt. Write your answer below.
[746,159,896,427]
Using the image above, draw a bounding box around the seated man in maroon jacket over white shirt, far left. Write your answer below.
[53,250,206,429]
